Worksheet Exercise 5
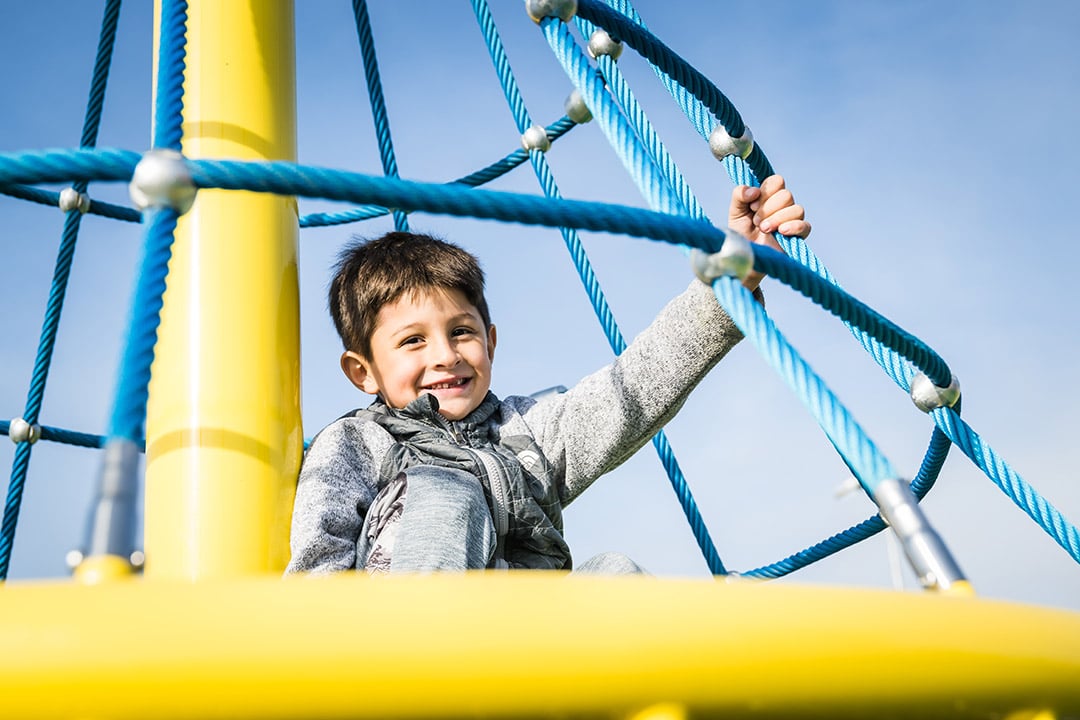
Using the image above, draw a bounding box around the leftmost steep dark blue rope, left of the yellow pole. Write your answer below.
[0,0,120,581]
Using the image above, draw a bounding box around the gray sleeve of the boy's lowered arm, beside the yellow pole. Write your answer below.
[285,418,389,574]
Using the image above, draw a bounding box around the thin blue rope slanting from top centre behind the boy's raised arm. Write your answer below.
[472,0,727,574]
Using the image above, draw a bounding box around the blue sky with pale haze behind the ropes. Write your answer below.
[0,0,1080,609]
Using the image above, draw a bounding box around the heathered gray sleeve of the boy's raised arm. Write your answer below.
[523,280,742,504]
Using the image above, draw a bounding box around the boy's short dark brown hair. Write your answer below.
[329,232,491,357]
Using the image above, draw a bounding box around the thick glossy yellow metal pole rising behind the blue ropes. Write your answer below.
[145,0,303,580]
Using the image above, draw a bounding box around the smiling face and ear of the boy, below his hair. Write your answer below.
[341,289,495,420]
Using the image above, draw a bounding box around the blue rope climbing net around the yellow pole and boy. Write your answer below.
[0,0,1080,591]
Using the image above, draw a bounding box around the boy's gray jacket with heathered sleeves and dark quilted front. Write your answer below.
[286,281,742,573]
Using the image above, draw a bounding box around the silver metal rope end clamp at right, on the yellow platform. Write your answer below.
[874,478,967,590]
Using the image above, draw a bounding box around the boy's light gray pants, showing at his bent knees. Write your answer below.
[356,465,645,574]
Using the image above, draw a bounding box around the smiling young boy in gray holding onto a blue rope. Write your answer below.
[286,176,810,573]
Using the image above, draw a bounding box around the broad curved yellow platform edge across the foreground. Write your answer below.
[0,572,1080,718]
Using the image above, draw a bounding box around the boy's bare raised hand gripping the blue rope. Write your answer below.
[728,175,810,290]
